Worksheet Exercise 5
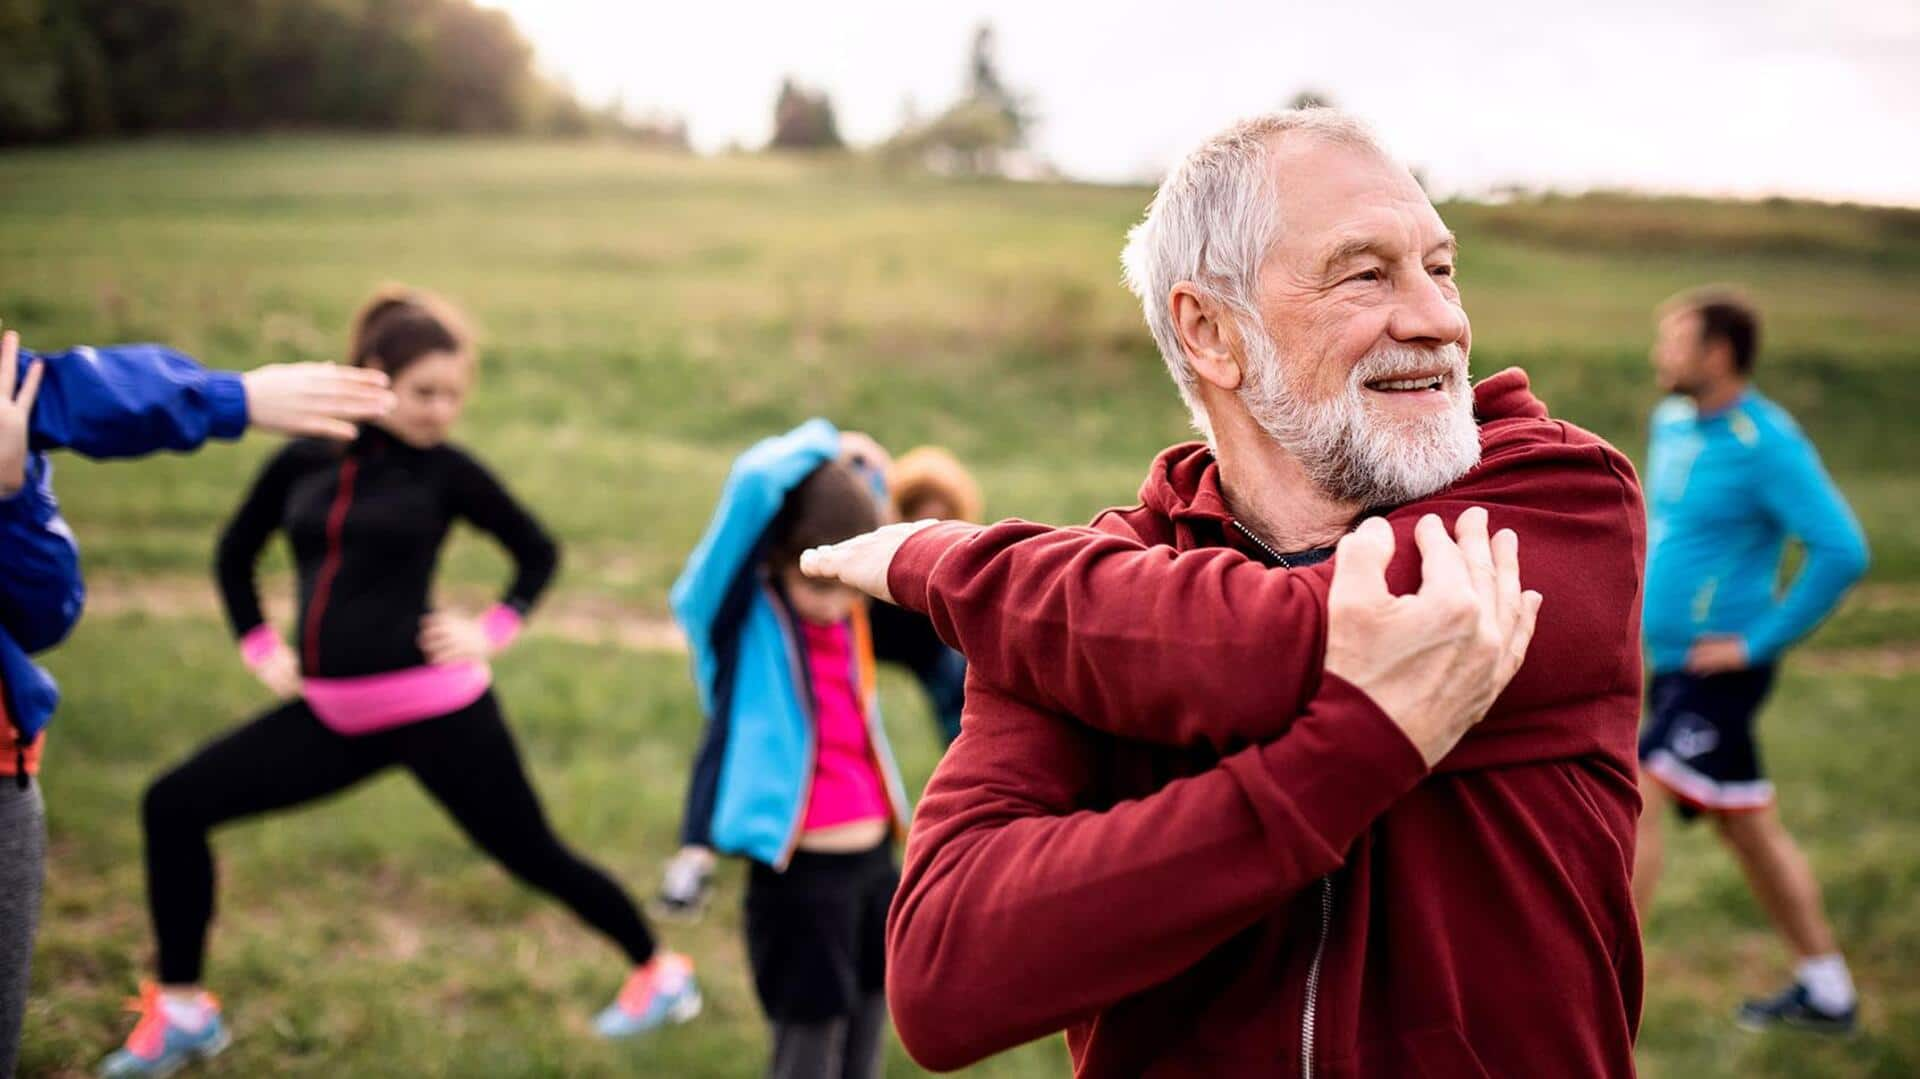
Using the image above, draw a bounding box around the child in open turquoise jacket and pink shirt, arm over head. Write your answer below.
[668,419,908,1079]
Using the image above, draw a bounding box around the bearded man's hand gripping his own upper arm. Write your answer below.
[1327,507,1542,768]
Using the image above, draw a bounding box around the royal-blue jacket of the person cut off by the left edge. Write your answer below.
[0,346,248,743]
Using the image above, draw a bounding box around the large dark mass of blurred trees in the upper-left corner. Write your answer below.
[0,0,685,144]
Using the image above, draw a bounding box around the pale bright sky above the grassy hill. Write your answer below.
[486,0,1920,205]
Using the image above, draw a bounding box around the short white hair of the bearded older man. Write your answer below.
[1119,108,1386,442]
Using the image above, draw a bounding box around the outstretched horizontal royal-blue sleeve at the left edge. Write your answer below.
[21,346,248,459]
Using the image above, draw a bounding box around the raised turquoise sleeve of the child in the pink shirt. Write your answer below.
[670,419,839,657]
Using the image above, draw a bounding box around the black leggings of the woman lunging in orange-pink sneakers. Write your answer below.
[142,693,653,985]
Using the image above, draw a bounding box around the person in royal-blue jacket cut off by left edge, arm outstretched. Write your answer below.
[0,322,392,1075]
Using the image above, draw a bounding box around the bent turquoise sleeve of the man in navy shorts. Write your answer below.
[1747,428,1866,662]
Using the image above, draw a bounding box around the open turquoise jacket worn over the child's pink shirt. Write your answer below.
[670,419,906,870]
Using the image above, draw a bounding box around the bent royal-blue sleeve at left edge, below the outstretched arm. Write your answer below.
[0,453,86,653]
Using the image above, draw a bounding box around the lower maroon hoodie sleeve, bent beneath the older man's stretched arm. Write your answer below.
[887,678,1427,1071]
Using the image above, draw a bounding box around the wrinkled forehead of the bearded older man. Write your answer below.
[1267,138,1452,263]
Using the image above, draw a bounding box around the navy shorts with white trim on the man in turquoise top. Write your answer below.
[1640,664,1774,818]
